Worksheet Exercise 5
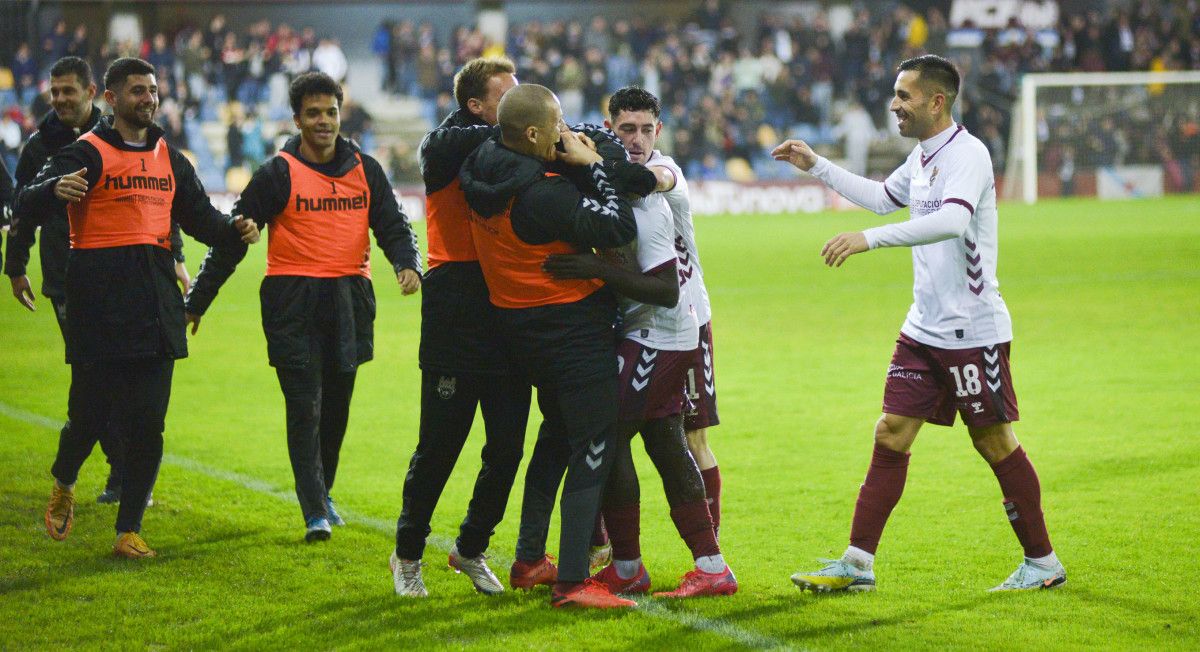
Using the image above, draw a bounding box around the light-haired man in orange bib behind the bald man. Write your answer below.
[390,58,530,597]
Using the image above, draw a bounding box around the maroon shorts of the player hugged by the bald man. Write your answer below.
[617,340,691,421]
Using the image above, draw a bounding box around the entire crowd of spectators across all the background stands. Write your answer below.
[0,0,1200,190]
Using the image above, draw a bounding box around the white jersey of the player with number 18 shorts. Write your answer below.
[865,125,1013,348]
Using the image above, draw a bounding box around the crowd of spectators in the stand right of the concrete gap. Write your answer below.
[372,0,1200,188]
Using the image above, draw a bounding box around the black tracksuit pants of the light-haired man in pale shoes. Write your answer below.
[396,370,532,560]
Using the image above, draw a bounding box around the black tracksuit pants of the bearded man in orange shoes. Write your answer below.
[50,358,175,532]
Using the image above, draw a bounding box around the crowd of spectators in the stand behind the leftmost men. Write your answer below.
[0,14,360,189]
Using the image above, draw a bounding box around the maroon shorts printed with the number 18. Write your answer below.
[883,334,1018,426]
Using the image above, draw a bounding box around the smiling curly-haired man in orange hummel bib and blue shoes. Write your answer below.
[180,72,421,542]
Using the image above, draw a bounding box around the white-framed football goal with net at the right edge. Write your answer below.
[1003,71,1200,204]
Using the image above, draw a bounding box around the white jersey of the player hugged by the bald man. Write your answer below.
[607,192,700,351]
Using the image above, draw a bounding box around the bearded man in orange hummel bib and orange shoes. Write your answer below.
[16,58,258,558]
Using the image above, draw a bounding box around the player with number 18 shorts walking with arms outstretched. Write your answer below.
[773,55,1067,591]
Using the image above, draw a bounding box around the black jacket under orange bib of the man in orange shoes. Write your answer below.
[14,116,241,364]
